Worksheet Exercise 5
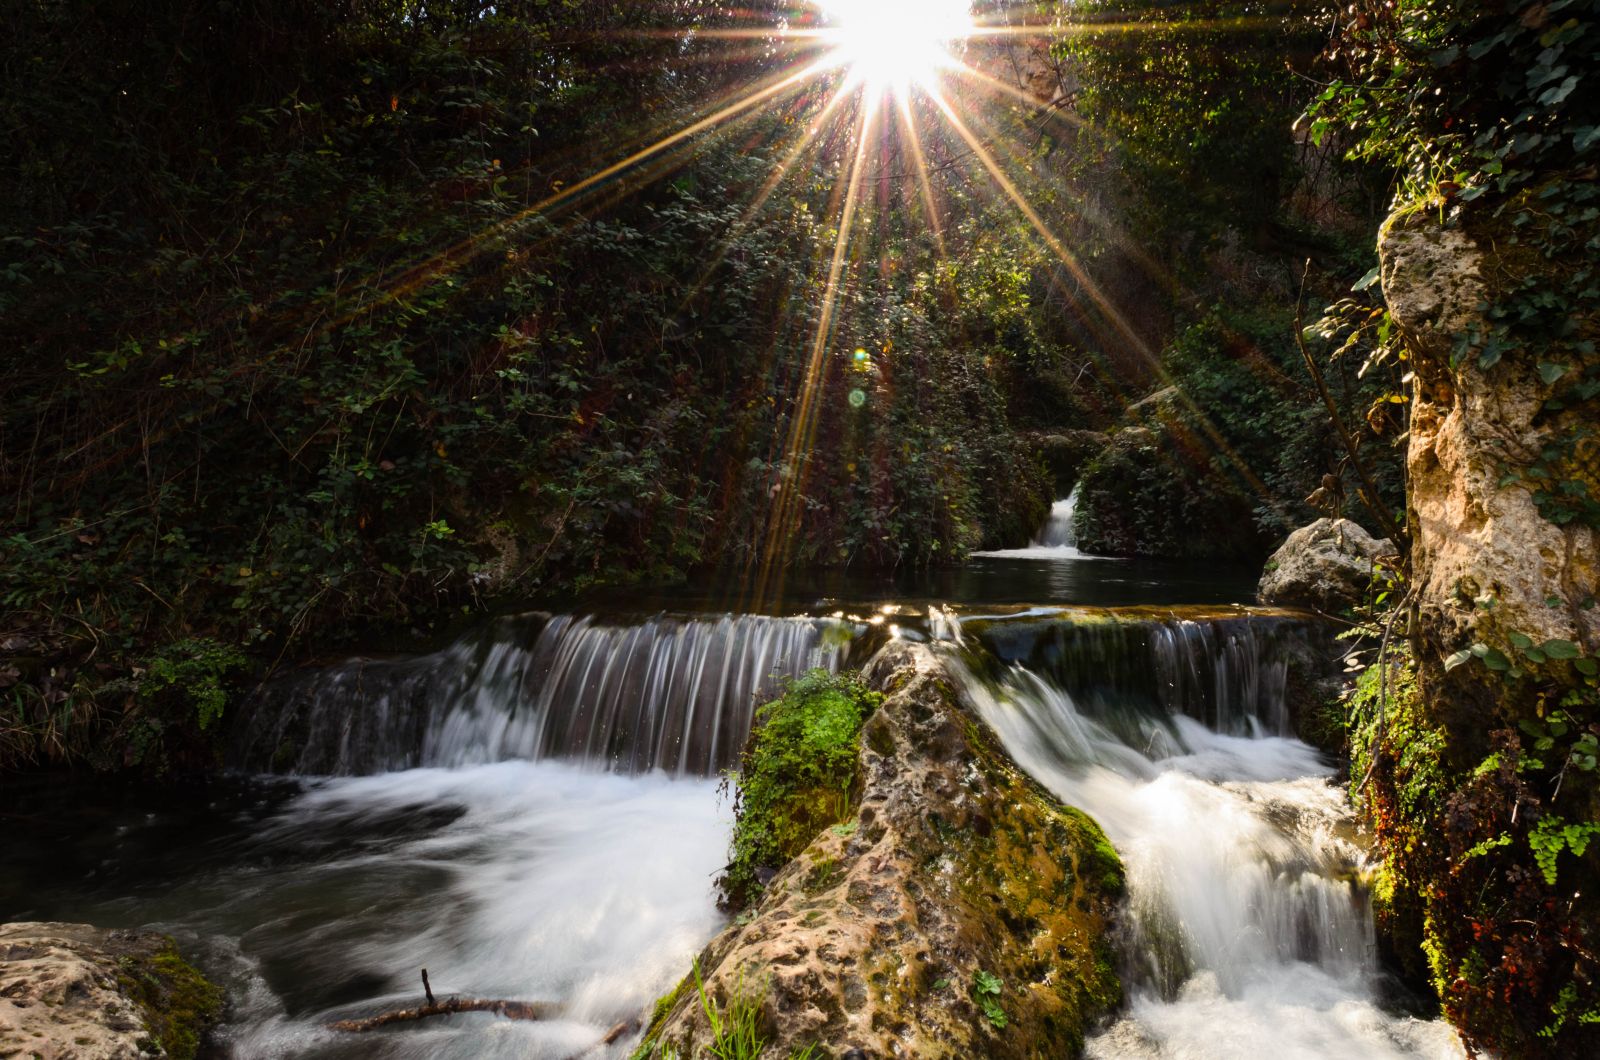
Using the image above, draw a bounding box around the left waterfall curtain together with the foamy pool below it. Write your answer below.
[12,615,858,1060]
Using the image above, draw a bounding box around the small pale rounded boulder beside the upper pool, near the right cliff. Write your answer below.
[1256,519,1395,613]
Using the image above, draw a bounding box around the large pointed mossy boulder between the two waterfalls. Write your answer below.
[635,644,1123,1060]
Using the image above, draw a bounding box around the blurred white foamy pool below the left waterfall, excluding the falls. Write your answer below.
[96,762,730,1060]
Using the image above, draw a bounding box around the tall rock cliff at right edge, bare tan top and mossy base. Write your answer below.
[1376,210,1600,1060]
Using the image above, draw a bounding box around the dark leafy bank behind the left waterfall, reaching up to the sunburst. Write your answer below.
[0,0,1114,765]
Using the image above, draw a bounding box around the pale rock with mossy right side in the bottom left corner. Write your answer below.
[0,922,222,1060]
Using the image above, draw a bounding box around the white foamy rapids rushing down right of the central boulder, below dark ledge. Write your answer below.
[952,661,1464,1060]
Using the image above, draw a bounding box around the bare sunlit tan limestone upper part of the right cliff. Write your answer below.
[1379,215,1600,698]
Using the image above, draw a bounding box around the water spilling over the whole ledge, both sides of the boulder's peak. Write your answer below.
[230,605,1307,777]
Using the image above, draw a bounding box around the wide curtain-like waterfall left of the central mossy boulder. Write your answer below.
[230,615,853,775]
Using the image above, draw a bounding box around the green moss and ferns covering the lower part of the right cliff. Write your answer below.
[1350,637,1600,1057]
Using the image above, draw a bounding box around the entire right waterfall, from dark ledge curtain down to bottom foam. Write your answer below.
[946,621,1461,1060]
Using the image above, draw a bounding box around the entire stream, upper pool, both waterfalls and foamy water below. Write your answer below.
[0,544,1462,1060]
